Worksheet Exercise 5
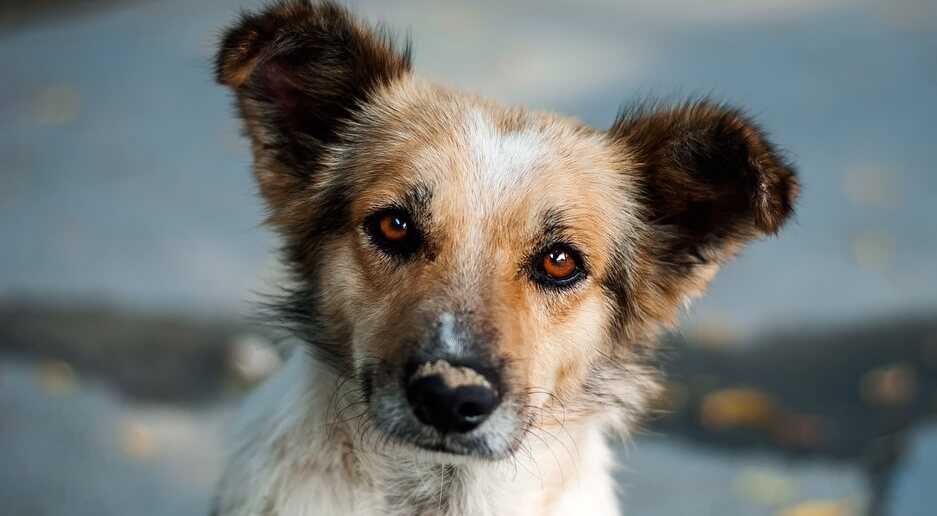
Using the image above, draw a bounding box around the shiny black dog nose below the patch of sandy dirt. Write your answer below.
[407,375,498,433]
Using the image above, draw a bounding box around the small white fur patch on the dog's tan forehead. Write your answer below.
[466,109,546,200]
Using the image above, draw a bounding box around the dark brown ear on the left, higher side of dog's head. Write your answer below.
[215,0,410,211]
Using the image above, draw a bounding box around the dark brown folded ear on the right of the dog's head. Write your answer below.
[609,102,798,316]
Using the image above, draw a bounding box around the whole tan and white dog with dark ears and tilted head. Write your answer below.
[213,0,798,516]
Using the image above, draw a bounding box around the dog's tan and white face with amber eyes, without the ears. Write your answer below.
[319,91,640,454]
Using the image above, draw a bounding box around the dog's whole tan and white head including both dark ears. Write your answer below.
[218,2,797,458]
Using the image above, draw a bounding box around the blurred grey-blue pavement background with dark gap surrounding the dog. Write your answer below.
[0,0,937,516]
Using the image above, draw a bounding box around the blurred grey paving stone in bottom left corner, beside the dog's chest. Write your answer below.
[0,360,229,516]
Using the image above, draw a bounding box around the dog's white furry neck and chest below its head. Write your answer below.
[222,350,614,516]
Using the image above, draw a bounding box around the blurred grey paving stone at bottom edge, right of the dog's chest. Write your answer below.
[618,437,868,516]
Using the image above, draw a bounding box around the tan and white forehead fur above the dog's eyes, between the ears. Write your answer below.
[348,81,633,246]
